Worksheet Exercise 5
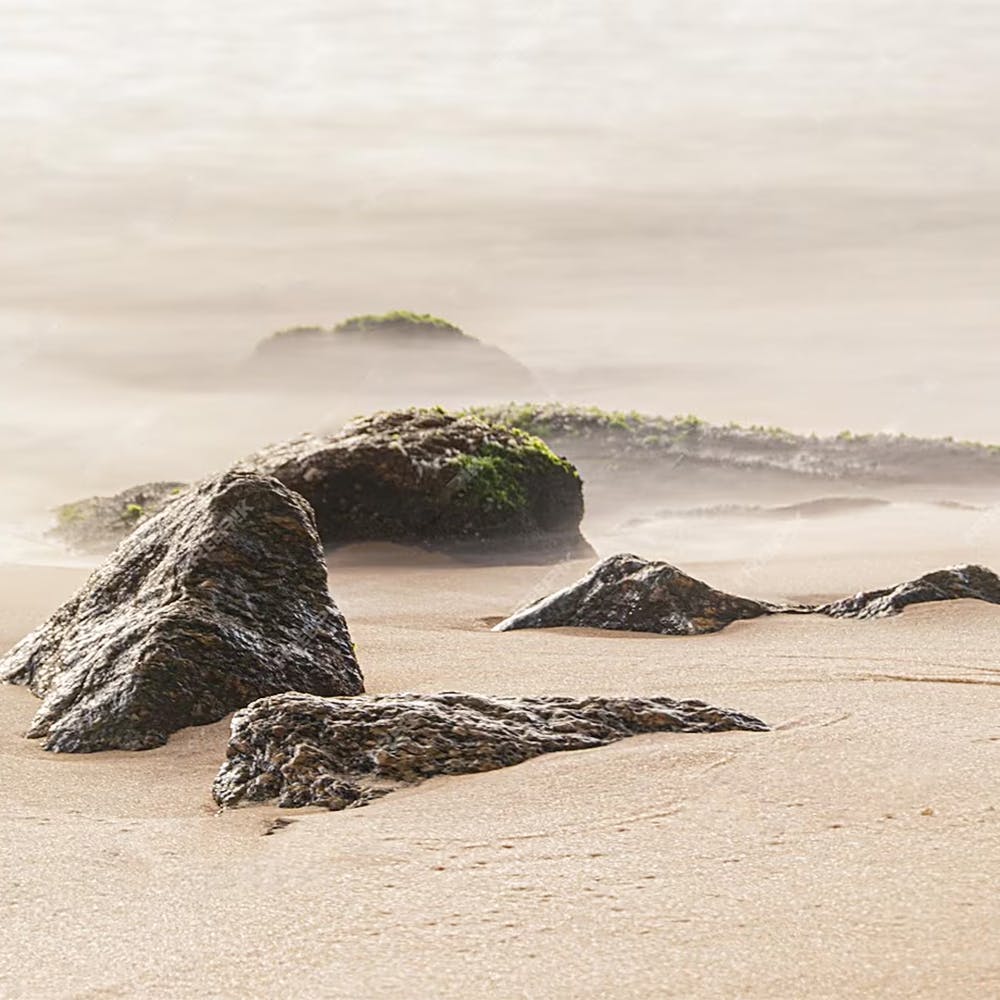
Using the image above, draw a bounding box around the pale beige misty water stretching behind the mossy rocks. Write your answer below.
[0,0,1000,564]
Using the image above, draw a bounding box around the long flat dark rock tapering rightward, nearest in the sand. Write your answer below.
[213,692,767,809]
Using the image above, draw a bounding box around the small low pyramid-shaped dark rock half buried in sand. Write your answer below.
[494,555,780,635]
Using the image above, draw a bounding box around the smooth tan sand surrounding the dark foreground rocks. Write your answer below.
[0,550,1000,998]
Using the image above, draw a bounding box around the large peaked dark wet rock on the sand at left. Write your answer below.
[0,473,363,751]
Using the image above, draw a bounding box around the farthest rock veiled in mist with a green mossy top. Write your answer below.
[249,310,541,406]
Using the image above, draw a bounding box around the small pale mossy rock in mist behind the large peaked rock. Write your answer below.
[50,483,187,552]
